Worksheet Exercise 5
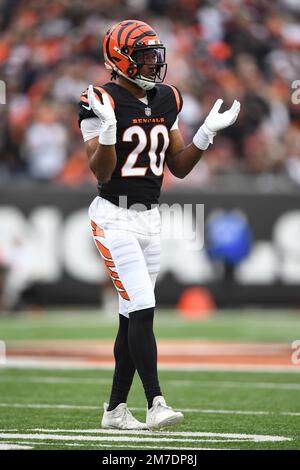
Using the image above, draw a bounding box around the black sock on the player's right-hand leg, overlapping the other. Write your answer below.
[128,307,161,408]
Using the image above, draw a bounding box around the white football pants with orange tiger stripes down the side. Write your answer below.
[89,196,160,318]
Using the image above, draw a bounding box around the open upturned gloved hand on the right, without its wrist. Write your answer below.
[204,98,241,132]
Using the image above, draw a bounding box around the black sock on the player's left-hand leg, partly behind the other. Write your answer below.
[107,315,135,411]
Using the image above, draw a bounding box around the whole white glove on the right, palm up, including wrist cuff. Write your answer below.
[193,98,241,150]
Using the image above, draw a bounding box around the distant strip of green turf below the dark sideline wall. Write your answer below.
[0,309,300,343]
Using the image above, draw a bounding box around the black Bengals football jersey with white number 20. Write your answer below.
[78,82,182,209]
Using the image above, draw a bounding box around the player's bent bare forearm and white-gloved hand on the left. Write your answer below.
[80,85,117,183]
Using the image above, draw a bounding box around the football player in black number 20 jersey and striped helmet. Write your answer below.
[79,20,240,429]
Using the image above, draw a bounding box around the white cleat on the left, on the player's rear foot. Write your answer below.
[101,403,148,430]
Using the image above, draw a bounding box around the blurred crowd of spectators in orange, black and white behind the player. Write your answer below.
[0,0,300,187]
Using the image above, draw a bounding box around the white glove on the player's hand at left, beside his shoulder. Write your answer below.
[88,85,117,145]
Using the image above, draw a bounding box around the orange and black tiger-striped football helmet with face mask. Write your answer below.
[103,20,167,89]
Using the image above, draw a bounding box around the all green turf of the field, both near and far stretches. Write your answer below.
[0,311,300,450]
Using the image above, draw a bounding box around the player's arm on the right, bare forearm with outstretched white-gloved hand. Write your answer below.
[166,99,240,178]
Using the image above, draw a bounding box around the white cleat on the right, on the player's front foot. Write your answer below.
[146,396,183,430]
